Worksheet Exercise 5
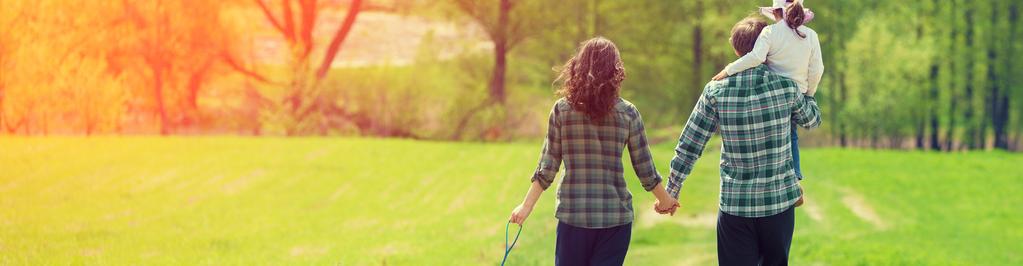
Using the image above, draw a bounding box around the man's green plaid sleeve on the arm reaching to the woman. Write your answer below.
[666,85,718,198]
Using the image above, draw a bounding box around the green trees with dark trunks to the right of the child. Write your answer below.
[812,0,1023,150]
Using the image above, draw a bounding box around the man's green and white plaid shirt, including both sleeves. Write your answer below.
[667,64,820,217]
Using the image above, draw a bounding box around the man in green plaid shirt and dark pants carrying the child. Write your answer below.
[655,17,820,265]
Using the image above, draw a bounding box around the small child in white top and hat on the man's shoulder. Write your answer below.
[714,0,825,206]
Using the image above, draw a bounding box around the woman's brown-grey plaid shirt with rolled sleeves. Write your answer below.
[531,98,661,228]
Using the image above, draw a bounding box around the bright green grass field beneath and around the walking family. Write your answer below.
[0,137,1023,265]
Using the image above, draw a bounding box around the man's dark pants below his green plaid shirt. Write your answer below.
[717,208,795,266]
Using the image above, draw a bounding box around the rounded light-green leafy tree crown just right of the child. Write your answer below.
[836,15,934,145]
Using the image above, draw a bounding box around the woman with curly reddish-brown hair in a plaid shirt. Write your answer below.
[509,37,678,265]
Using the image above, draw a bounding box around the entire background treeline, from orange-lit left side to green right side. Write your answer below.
[0,0,1023,150]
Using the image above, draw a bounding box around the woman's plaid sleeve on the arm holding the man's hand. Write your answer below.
[627,107,661,191]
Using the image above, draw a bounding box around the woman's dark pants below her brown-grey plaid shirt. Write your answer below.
[554,219,632,266]
